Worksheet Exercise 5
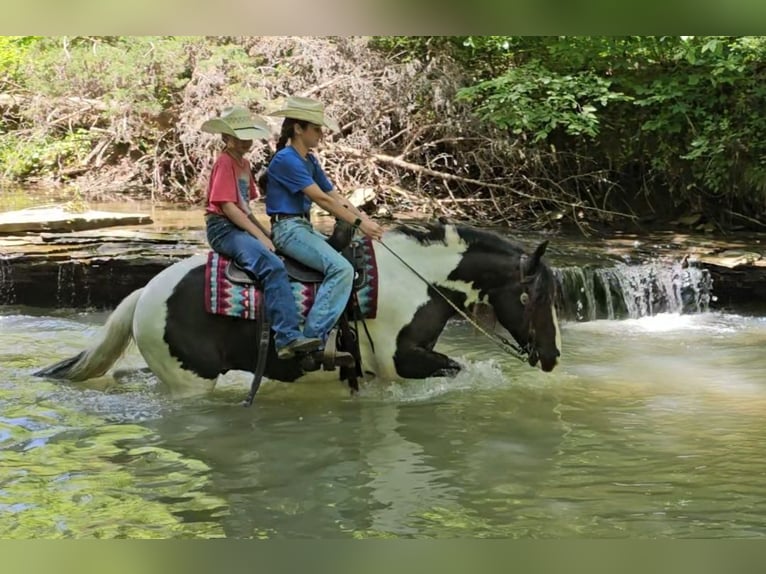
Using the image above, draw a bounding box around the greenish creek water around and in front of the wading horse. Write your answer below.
[0,307,766,538]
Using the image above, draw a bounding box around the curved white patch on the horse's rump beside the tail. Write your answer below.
[133,256,215,395]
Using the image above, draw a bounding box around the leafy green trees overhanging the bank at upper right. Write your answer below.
[448,36,766,219]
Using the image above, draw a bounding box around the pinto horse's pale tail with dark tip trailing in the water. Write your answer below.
[34,289,143,381]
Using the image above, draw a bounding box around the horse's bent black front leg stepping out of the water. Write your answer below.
[394,295,462,379]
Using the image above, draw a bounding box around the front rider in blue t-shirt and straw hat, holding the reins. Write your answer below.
[266,96,383,358]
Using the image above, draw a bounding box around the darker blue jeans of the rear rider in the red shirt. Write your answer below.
[210,215,303,349]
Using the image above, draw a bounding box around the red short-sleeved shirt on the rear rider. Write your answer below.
[205,152,260,215]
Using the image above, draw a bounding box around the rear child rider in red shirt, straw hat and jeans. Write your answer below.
[201,106,322,359]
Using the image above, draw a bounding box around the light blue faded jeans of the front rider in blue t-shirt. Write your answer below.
[271,217,354,341]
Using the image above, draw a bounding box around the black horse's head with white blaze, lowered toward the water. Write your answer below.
[486,241,561,372]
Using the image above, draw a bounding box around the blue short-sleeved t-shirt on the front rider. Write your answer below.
[266,146,333,215]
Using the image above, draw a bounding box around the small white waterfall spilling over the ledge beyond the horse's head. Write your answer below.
[556,260,713,321]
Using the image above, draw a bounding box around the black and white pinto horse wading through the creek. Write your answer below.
[36,223,561,395]
